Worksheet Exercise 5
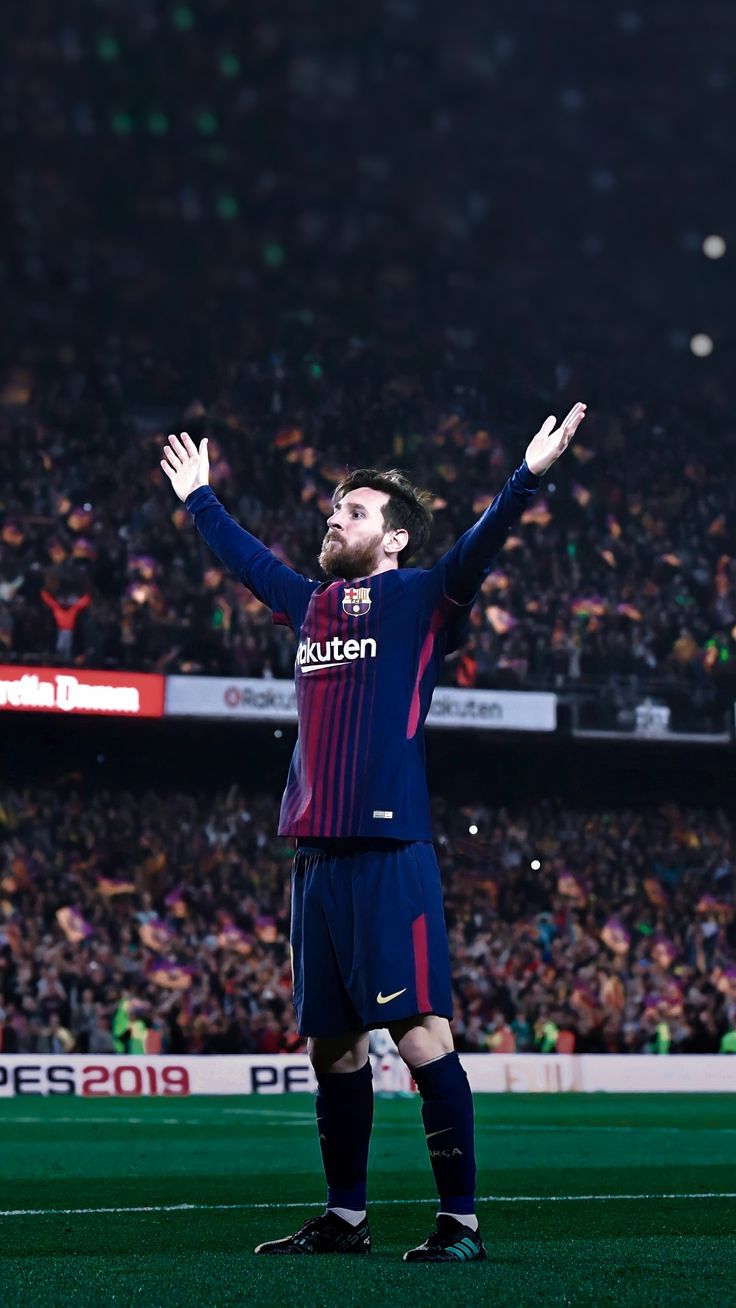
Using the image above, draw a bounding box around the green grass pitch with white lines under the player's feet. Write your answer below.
[0,1095,736,1308]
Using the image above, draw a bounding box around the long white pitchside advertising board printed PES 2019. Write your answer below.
[0,1054,736,1108]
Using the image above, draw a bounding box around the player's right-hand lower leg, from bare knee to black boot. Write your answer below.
[391,1015,486,1262]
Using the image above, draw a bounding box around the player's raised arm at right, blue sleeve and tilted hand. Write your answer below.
[433,404,586,604]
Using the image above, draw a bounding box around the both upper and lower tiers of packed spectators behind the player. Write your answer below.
[0,0,736,1052]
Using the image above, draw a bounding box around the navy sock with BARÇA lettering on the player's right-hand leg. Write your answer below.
[412,1053,476,1214]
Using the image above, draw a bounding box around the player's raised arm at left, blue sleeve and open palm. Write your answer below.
[161,432,318,632]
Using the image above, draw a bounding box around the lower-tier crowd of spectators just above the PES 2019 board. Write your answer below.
[0,776,736,1054]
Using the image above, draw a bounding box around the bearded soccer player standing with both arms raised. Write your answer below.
[161,404,586,1262]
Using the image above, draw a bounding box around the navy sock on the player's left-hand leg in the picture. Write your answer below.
[316,1061,373,1213]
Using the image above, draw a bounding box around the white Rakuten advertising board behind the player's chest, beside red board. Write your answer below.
[165,676,557,731]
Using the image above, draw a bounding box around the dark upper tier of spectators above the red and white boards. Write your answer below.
[0,0,736,725]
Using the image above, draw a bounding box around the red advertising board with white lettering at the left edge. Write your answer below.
[0,664,166,718]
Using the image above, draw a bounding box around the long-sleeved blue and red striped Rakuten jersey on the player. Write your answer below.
[187,463,540,840]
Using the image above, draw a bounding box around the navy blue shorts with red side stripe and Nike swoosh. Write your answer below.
[292,837,452,1036]
